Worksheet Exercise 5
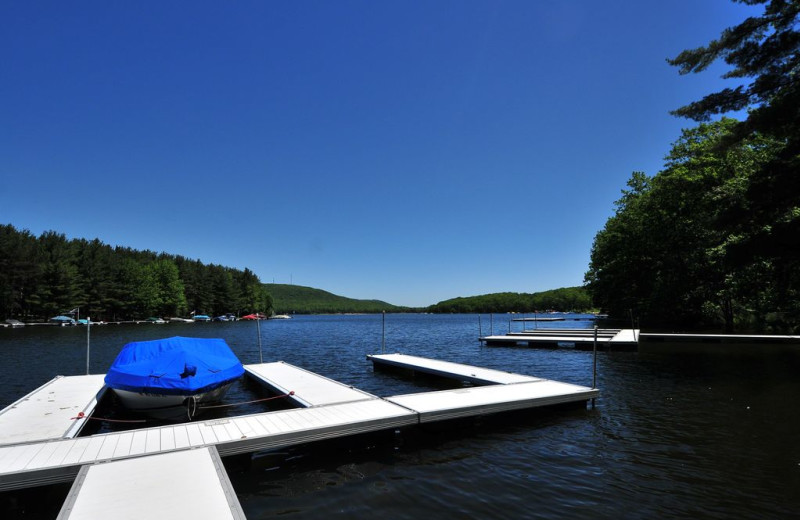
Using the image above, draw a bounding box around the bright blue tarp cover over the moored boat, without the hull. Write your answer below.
[105,336,244,395]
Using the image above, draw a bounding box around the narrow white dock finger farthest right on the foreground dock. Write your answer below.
[367,354,542,385]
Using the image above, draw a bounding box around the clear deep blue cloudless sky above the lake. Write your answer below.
[0,0,760,306]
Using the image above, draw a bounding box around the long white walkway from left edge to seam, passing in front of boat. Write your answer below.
[0,398,418,491]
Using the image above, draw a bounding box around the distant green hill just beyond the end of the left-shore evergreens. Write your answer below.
[263,283,407,314]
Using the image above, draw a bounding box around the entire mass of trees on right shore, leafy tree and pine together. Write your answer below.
[586,0,800,333]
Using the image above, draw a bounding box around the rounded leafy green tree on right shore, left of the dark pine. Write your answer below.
[586,119,786,330]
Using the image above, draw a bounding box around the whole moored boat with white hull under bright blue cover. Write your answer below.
[105,336,244,421]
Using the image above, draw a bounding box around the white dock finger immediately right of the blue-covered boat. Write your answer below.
[244,361,377,408]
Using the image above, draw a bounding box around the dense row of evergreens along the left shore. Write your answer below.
[0,225,272,321]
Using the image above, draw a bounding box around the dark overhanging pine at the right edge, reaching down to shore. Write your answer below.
[669,0,800,330]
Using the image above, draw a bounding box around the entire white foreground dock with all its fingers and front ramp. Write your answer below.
[0,354,599,520]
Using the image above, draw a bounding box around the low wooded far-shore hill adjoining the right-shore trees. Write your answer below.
[427,287,592,313]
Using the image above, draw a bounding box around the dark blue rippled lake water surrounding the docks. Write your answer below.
[0,314,800,520]
